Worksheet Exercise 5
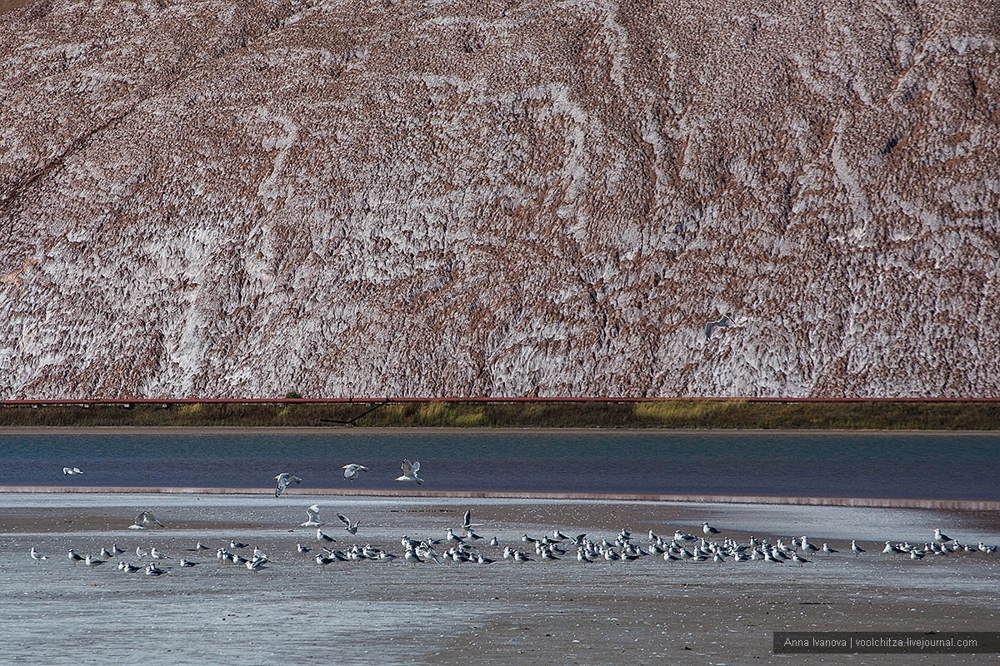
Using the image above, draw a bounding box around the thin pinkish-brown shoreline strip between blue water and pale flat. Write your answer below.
[0,486,1000,511]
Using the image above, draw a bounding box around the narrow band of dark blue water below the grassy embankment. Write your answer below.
[0,430,1000,500]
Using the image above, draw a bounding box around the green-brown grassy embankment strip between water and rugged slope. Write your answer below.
[0,399,1000,430]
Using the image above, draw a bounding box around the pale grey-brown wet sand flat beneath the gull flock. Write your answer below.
[0,493,1000,664]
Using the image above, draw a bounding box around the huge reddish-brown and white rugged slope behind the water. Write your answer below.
[0,0,1000,398]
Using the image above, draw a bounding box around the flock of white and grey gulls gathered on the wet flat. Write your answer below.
[30,504,997,576]
